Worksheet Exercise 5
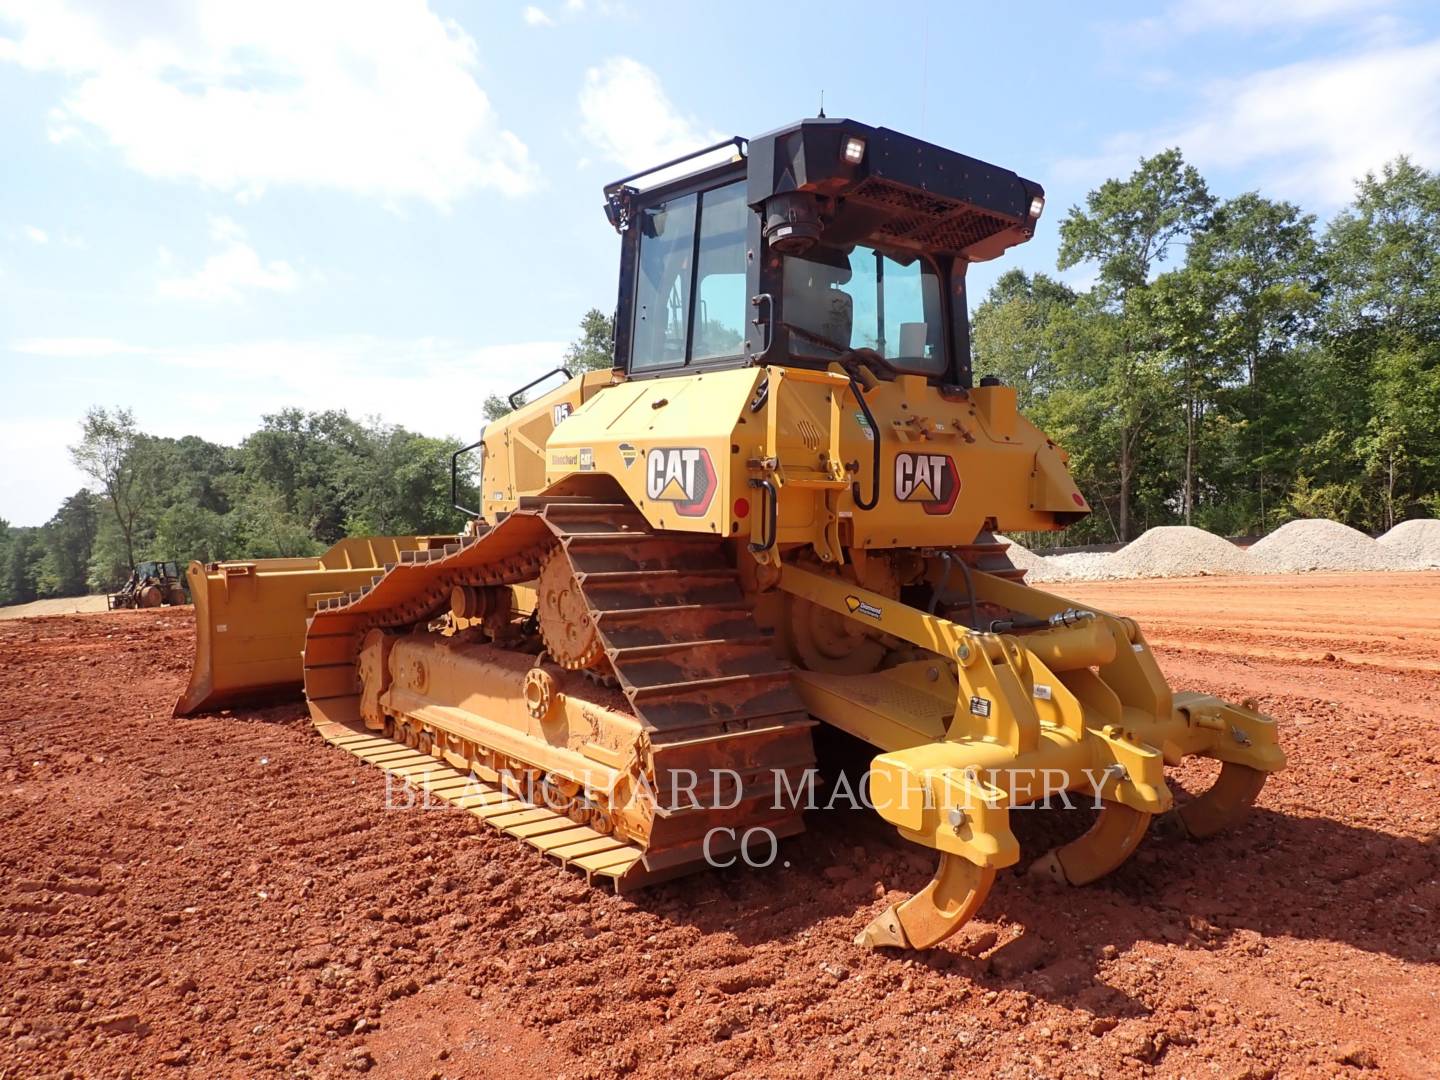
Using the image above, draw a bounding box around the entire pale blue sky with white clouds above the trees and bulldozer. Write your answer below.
[0,0,1440,524]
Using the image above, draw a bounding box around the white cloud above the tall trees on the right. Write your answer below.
[1057,40,1440,207]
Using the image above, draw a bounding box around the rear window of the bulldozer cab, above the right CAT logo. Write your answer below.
[780,245,946,376]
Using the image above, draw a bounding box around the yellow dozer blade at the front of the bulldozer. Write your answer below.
[174,536,454,716]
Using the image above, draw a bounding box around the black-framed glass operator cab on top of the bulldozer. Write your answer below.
[605,118,1044,387]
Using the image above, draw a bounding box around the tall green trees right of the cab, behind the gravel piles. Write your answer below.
[972,150,1440,544]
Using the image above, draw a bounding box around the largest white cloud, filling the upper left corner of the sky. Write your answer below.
[0,0,539,207]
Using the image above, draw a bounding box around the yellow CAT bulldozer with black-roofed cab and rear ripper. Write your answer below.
[177,118,1284,949]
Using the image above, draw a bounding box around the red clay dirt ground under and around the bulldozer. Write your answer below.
[0,573,1440,1080]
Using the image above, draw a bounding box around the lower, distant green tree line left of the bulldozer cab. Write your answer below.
[0,311,613,605]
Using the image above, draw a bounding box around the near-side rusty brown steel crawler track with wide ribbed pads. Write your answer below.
[305,498,814,888]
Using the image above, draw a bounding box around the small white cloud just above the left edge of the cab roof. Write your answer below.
[580,56,724,177]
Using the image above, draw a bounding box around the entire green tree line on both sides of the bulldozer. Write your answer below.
[0,150,1440,603]
